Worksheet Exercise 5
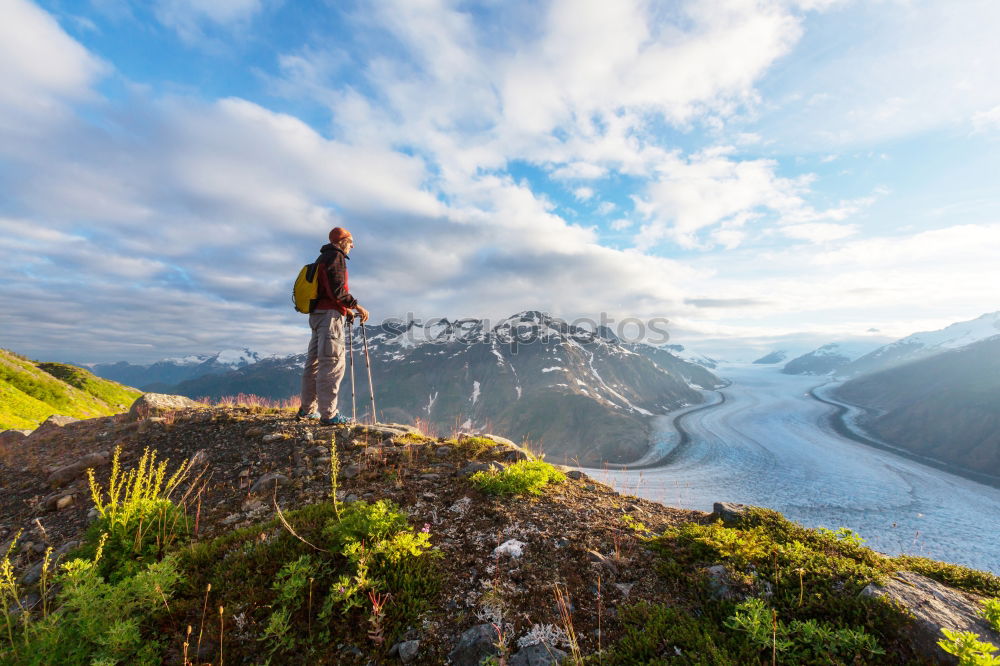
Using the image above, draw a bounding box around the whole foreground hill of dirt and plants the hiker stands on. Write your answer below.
[0,402,1000,666]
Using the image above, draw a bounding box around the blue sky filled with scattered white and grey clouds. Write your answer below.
[0,0,1000,361]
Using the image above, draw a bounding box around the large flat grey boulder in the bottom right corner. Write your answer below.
[861,571,1000,663]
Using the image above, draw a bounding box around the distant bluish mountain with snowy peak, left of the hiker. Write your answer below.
[91,348,273,391]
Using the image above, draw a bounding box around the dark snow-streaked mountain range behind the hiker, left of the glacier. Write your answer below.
[174,310,721,463]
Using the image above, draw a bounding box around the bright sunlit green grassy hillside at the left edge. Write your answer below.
[0,349,141,430]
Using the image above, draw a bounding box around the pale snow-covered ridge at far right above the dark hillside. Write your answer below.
[838,311,1000,376]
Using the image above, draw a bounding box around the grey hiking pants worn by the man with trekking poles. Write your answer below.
[301,310,347,419]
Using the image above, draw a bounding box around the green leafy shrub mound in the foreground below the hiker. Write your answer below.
[182,500,440,663]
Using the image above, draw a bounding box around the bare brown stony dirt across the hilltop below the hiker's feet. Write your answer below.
[0,408,708,663]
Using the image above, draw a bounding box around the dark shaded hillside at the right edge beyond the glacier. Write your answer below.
[835,335,1000,477]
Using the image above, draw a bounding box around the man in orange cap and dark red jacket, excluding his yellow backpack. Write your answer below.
[297,227,368,425]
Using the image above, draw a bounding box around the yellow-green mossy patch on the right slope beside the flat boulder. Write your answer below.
[616,508,928,663]
